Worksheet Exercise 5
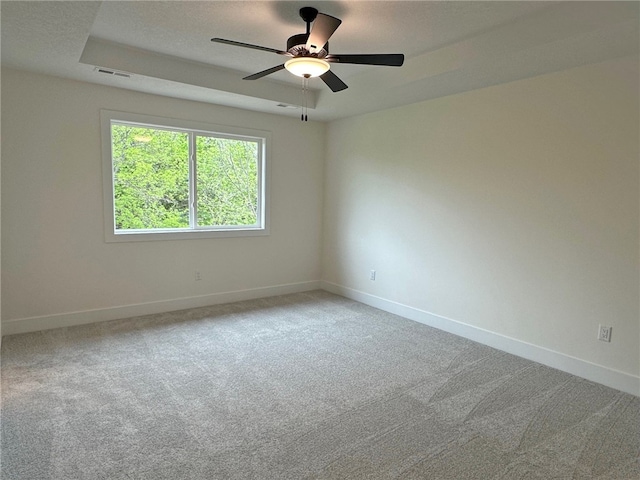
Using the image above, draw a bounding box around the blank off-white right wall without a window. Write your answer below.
[323,58,640,392]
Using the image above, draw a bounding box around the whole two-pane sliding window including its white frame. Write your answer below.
[101,111,269,241]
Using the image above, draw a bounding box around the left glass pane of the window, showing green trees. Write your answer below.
[111,124,189,230]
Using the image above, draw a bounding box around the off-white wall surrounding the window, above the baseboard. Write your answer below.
[2,69,325,334]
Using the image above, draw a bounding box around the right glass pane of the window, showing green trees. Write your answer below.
[196,136,258,227]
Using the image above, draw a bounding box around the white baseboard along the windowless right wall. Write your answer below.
[320,281,640,396]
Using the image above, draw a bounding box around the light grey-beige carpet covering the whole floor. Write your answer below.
[1,291,640,480]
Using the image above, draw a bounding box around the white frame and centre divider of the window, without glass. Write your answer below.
[100,110,271,242]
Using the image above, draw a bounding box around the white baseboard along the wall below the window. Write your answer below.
[2,281,320,335]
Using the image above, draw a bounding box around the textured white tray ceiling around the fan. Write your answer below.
[1,1,640,120]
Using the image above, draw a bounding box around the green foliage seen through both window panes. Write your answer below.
[111,122,261,231]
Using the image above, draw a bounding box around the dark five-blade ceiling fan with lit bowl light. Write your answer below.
[211,7,404,92]
